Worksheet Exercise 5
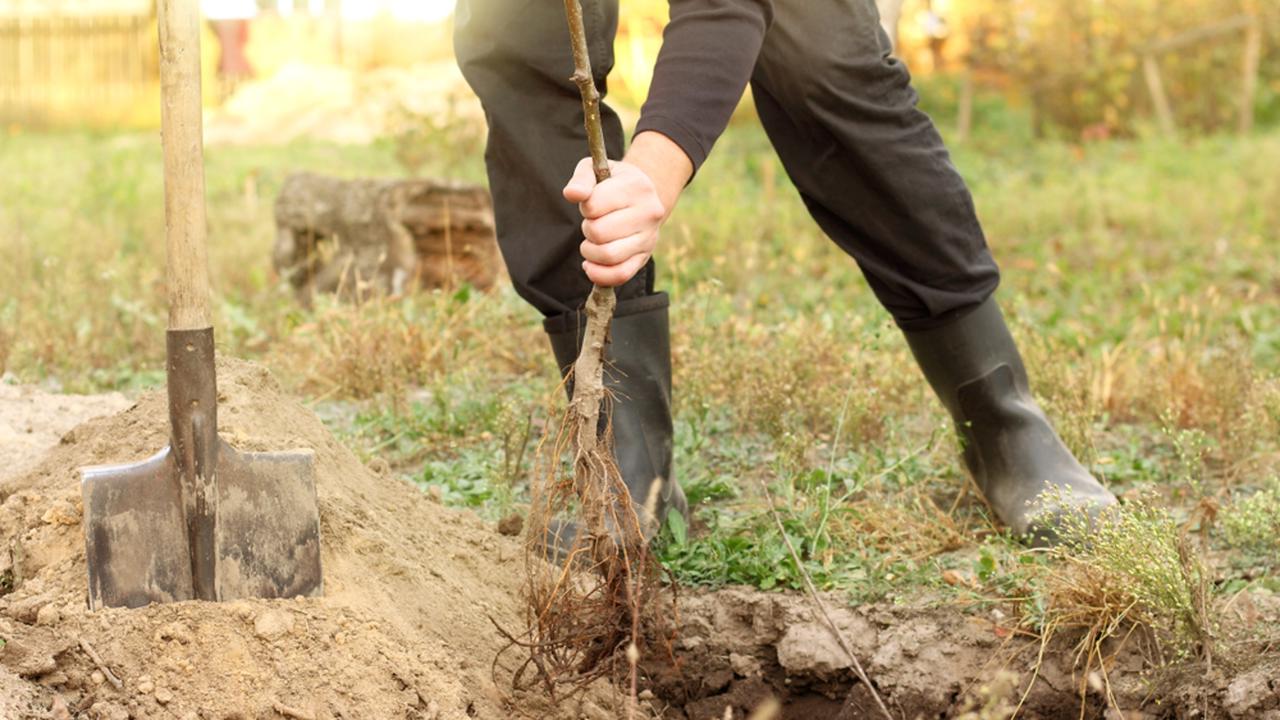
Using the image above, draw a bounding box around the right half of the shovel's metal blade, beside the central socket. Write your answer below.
[216,439,324,600]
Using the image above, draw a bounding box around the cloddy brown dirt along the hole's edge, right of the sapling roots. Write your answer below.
[644,588,1280,720]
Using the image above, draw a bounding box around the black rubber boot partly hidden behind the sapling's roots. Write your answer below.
[543,293,689,547]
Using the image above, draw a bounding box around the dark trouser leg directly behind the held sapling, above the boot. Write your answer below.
[454,0,653,316]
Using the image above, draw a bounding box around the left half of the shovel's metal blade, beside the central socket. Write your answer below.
[81,446,193,610]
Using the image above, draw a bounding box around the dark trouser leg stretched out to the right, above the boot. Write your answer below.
[751,0,1000,329]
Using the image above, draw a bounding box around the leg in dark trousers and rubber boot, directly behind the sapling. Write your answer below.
[454,0,687,551]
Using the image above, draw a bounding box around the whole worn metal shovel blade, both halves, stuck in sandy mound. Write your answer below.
[82,438,323,609]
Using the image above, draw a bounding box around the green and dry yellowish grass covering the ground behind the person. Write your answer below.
[0,105,1280,691]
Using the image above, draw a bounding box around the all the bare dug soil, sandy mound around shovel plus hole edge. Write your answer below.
[0,361,1280,720]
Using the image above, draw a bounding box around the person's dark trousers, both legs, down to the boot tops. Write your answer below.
[454,0,1000,331]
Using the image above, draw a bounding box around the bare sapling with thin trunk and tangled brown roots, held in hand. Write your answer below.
[494,0,675,702]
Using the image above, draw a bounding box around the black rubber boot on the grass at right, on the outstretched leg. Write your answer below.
[905,299,1116,546]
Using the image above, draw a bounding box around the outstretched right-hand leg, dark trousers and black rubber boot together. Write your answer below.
[751,0,1115,544]
